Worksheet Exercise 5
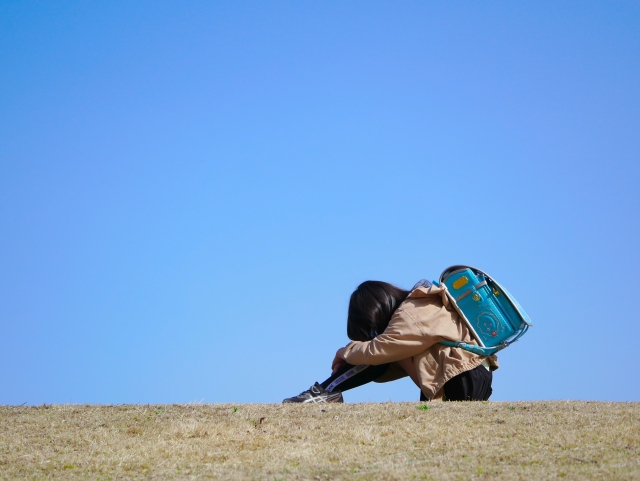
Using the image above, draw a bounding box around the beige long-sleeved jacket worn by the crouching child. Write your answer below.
[344,286,498,399]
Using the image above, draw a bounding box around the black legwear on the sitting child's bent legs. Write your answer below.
[321,364,493,401]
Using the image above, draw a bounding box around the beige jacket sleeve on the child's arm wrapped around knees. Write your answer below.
[344,311,444,365]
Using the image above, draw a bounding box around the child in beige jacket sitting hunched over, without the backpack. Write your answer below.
[283,281,498,403]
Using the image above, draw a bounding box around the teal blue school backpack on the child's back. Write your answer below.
[433,266,532,356]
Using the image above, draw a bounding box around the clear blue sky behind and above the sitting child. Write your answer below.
[0,1,640,404]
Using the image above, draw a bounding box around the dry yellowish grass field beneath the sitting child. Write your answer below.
[0,402,640,480]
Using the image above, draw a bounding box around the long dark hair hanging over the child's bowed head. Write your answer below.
[347,281,409,341]
